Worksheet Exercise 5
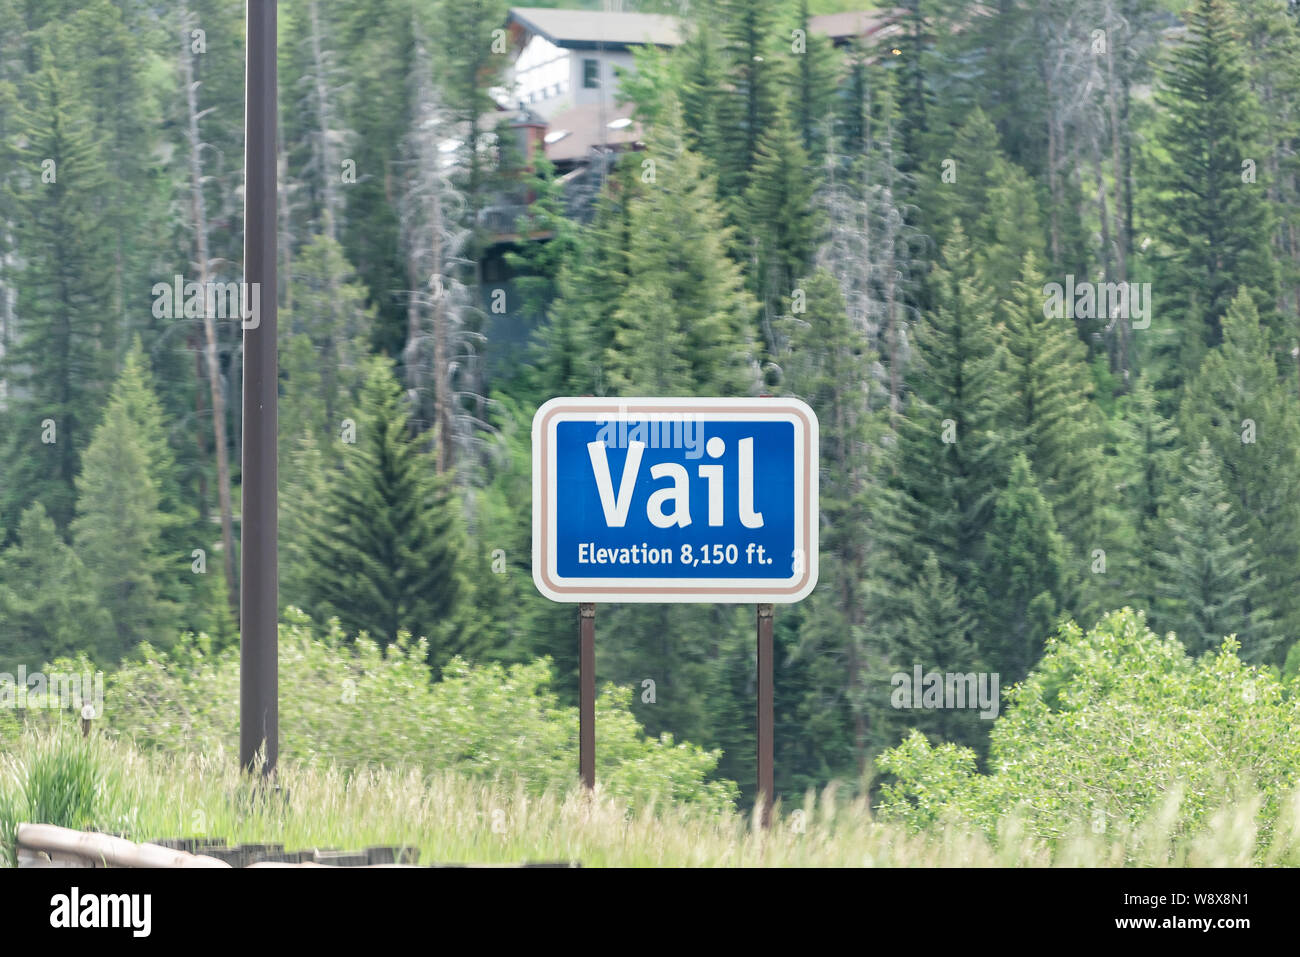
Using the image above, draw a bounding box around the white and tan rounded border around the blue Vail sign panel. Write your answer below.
[532,397,819,605]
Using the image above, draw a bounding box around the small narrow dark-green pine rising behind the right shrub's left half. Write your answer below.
[980,452,1067,687]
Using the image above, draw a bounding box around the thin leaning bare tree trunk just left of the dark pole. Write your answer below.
[181,5,239,622]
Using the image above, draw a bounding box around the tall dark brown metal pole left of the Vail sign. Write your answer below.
[239,0,280,775]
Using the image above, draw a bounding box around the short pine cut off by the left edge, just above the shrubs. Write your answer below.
[0,502,113,675]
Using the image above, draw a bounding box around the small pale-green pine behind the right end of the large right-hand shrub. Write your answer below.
[1153,439,1281,662]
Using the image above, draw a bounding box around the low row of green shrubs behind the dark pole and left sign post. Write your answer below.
[78,610,737,809]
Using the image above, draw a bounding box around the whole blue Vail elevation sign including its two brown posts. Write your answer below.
[533,397,818,826]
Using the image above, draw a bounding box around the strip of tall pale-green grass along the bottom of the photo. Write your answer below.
[0,732,1300,867]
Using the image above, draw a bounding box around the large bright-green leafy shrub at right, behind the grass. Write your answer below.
[878,609,1300,846]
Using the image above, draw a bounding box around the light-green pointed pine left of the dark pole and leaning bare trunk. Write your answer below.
[72,354,189,662]
